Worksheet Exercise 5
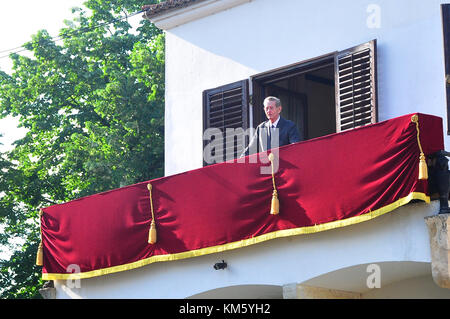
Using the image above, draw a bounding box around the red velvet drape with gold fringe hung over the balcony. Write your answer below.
[41,114,443,279]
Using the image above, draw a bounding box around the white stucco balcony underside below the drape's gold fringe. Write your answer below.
[56,201,442,298]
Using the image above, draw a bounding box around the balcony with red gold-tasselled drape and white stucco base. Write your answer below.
[37,114,450,298]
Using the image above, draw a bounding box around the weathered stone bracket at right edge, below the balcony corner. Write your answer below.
[425,214,450,288]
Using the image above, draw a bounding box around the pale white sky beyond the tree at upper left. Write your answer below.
[0,0,86,151]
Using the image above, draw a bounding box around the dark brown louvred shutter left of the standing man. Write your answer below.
[203,80,249,165]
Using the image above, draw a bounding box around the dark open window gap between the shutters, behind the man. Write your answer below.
[253,57,336,140]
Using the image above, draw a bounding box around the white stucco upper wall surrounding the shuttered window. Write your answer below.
[165,0,450,175]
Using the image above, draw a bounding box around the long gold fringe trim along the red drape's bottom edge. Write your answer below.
[42,192,430,280]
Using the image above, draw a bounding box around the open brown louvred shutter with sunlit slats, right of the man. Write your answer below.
[335,40,378,132]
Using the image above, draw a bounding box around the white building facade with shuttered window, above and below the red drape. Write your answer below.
[49,0,450,298]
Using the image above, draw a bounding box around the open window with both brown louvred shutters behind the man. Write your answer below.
[203,40,377,165]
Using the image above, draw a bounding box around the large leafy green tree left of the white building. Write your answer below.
[0,0,164,298]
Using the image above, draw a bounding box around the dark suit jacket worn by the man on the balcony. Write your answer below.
[241,116,302,156]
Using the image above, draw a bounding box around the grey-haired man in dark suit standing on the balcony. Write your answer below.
[241,96,301,156]
